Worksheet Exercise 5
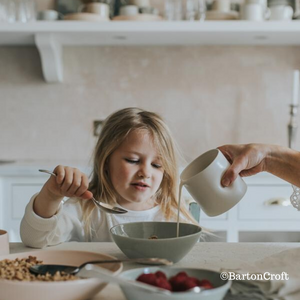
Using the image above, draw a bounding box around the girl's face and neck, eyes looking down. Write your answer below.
[108,130,164,210]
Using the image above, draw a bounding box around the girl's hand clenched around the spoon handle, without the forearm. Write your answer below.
[44,165,93,200]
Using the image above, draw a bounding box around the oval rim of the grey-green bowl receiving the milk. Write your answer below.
[110,221,202,242]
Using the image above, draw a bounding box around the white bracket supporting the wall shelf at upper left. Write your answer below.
[34,33,63,83]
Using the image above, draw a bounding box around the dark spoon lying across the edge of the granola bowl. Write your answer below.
[29,258,173,275]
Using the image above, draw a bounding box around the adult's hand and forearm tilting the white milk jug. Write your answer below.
[218,144,300,186]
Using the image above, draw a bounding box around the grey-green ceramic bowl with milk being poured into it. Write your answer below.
[110,222,201,263]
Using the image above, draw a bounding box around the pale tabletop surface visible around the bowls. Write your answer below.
[10,242,300,300]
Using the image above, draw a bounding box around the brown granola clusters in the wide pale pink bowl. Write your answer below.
[0,256,79,281]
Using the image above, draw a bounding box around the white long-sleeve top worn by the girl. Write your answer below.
[20,194,183,248]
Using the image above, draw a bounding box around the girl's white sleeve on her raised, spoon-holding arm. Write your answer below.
[20,194,85,248]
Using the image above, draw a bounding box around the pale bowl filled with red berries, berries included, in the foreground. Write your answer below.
[119,267,231,300]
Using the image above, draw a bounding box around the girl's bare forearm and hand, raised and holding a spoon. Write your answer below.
[33,165,93,218]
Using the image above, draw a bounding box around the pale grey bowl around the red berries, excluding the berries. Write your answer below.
[119,267,231,300]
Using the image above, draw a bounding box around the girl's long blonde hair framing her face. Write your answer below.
[81,107,197,238]
